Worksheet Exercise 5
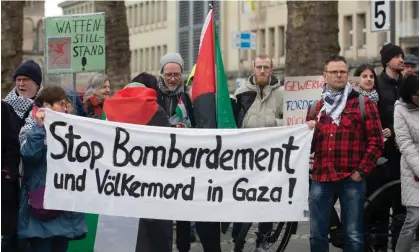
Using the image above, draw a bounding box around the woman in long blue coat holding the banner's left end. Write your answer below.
[18,86,87,252]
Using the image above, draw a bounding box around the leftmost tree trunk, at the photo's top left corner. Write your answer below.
[1,1,25,98]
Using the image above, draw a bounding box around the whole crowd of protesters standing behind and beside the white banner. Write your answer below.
[1,44,419,252]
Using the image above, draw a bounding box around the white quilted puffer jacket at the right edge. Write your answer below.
[394,101,419,207]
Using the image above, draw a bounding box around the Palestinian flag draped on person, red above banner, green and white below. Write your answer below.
[67,87,169,252]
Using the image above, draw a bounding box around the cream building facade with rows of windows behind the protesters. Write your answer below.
[60,0,419,87]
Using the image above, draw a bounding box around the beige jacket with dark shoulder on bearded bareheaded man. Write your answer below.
[234,75,284,128]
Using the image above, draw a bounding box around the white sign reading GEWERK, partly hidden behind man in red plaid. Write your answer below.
[284,75,360,126]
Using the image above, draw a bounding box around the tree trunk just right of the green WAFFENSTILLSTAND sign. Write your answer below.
[94,1,131,90]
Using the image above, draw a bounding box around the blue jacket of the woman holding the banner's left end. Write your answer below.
[18,125,87,239]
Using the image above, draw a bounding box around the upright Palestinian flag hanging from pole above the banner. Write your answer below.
[192,9,236,128]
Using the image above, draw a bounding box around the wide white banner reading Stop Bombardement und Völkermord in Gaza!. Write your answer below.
[44,110,313,222]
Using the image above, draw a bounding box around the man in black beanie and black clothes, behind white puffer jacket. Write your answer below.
[377,43,405,250]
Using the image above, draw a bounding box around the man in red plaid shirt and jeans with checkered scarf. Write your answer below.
[307,56,384,252]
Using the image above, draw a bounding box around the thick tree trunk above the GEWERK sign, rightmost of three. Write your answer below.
[285,1,340,76]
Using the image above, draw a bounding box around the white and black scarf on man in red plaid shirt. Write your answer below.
[320,83,352,125]
